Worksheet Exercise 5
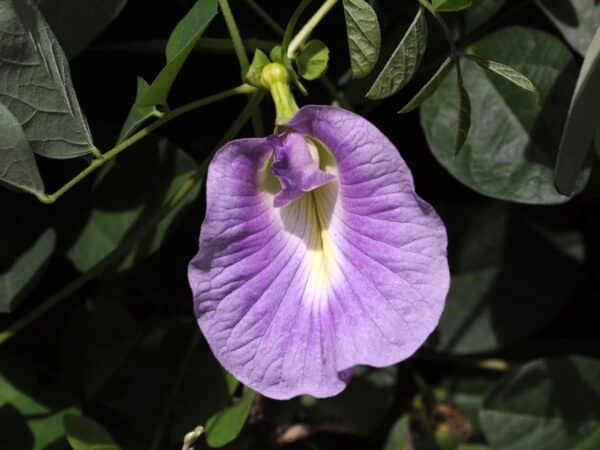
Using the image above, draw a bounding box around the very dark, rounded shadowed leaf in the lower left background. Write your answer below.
[60,298,138,398]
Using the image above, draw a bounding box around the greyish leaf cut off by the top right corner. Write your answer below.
[536,0,600,55]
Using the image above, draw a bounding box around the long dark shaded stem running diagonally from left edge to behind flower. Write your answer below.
[0,91,264,344]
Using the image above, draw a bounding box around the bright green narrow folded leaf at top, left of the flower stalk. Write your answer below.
[138,0,217,106]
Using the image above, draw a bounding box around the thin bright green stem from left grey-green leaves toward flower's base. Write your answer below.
[37,84,256,204]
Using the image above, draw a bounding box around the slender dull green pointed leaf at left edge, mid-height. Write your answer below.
[0,228,56,313]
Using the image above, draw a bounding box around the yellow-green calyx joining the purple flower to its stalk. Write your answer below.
[260,62,298,125]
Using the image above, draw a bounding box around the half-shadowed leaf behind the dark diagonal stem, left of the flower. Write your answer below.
[68,139,200,272]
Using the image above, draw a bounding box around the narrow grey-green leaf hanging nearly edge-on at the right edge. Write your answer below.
[556,28,600,195]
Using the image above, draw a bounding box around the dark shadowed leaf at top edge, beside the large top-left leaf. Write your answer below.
[36,0,127,59]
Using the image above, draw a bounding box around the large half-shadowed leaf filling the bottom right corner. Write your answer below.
[479,356,600,450]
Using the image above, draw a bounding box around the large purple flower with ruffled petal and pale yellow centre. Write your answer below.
[189,106,449,399]
